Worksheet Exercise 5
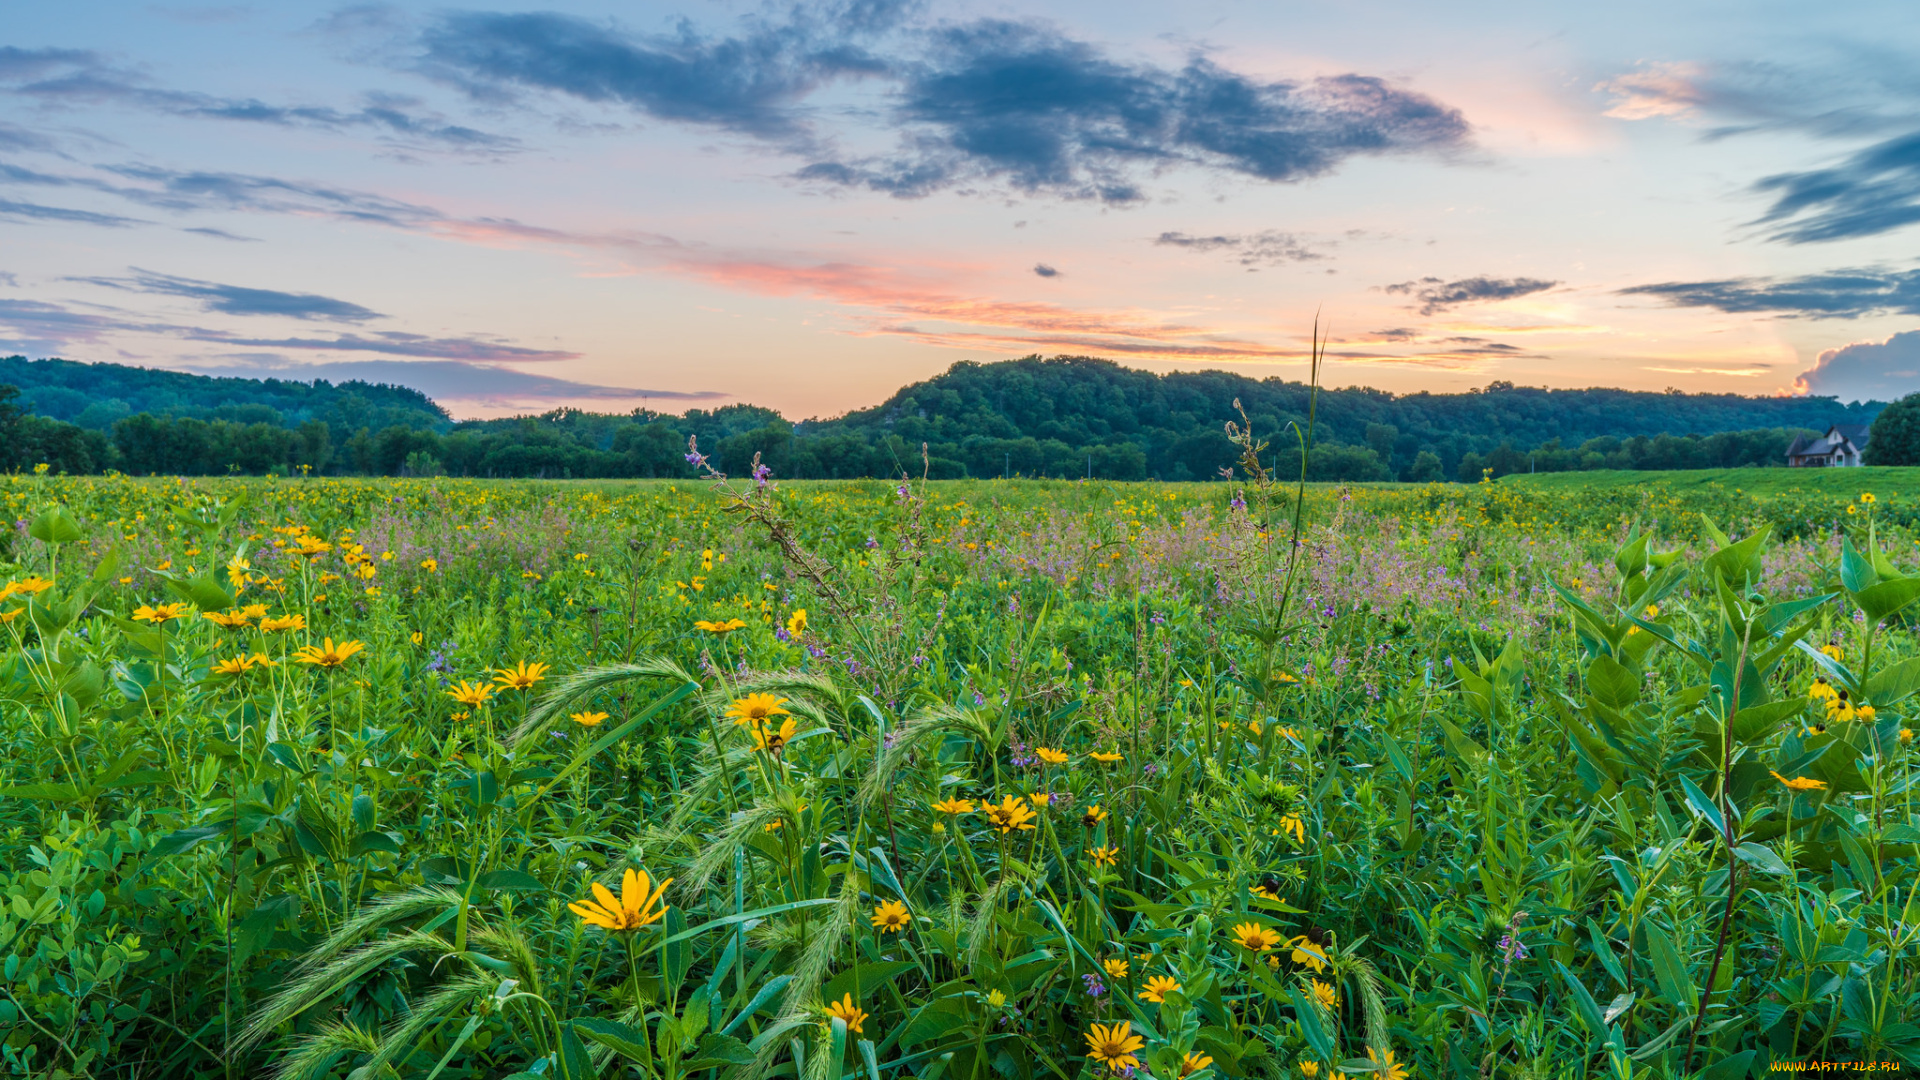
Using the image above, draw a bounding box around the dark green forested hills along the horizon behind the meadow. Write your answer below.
[0,356,1882,480]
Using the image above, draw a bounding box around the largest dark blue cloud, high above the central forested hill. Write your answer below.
[801,21,1469,204]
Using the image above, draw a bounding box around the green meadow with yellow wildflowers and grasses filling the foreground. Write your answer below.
[0,469,1920,1080]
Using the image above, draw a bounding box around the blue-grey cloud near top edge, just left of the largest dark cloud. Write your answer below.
[420,6,883,140]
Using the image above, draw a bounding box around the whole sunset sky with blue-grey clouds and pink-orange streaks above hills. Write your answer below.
[0,0,1920,419]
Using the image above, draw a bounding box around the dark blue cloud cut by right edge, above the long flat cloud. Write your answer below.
[1753,133,1920,244]
